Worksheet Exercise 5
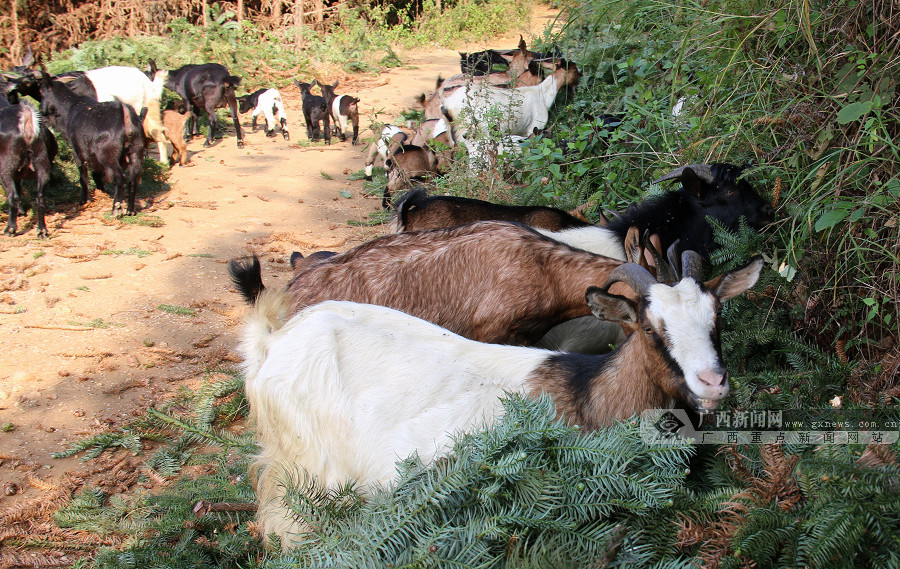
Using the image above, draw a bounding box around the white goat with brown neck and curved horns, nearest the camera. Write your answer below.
[240,252,763,547]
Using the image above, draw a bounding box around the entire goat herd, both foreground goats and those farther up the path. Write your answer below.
[0,42,773,547]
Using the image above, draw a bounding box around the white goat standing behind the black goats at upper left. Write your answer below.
[85,65,169,165]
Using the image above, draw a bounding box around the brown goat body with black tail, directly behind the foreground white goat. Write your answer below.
[230,221,634,345]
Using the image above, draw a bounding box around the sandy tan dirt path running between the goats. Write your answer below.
[0,8,552,510]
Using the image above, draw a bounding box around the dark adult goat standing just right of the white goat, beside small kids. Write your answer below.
[158,60,244,148]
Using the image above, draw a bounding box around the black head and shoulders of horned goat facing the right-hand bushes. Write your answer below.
[606,163,774,257]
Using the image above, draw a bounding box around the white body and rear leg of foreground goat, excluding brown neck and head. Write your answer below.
[241,293,550,544]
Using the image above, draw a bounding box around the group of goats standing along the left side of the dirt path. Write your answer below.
[0,46,359,238]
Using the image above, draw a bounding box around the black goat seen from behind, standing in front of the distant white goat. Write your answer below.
[38,72,147,217]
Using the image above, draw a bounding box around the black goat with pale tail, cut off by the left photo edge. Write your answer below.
[0,101,59,237]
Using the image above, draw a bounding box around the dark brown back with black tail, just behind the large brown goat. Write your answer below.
[396,188,590,232]
